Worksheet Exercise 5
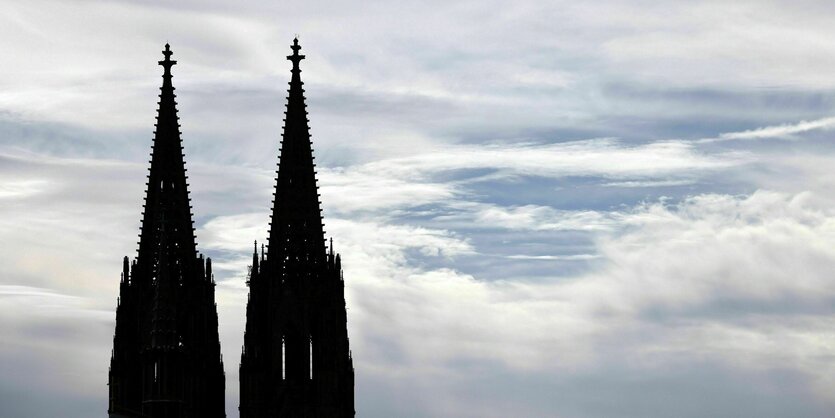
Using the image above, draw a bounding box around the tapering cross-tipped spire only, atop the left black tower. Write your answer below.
[137,44,197,278]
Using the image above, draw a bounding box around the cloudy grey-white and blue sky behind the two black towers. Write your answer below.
[0,0,835,418]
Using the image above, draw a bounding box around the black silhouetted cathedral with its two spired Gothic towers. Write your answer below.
[108,38,354,418]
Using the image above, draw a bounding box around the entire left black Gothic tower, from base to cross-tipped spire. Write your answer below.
[108,44,226,418]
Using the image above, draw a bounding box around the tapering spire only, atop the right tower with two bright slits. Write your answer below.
[267,38,325,262]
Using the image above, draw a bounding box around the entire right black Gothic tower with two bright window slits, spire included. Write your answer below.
[240,39,354,418]
